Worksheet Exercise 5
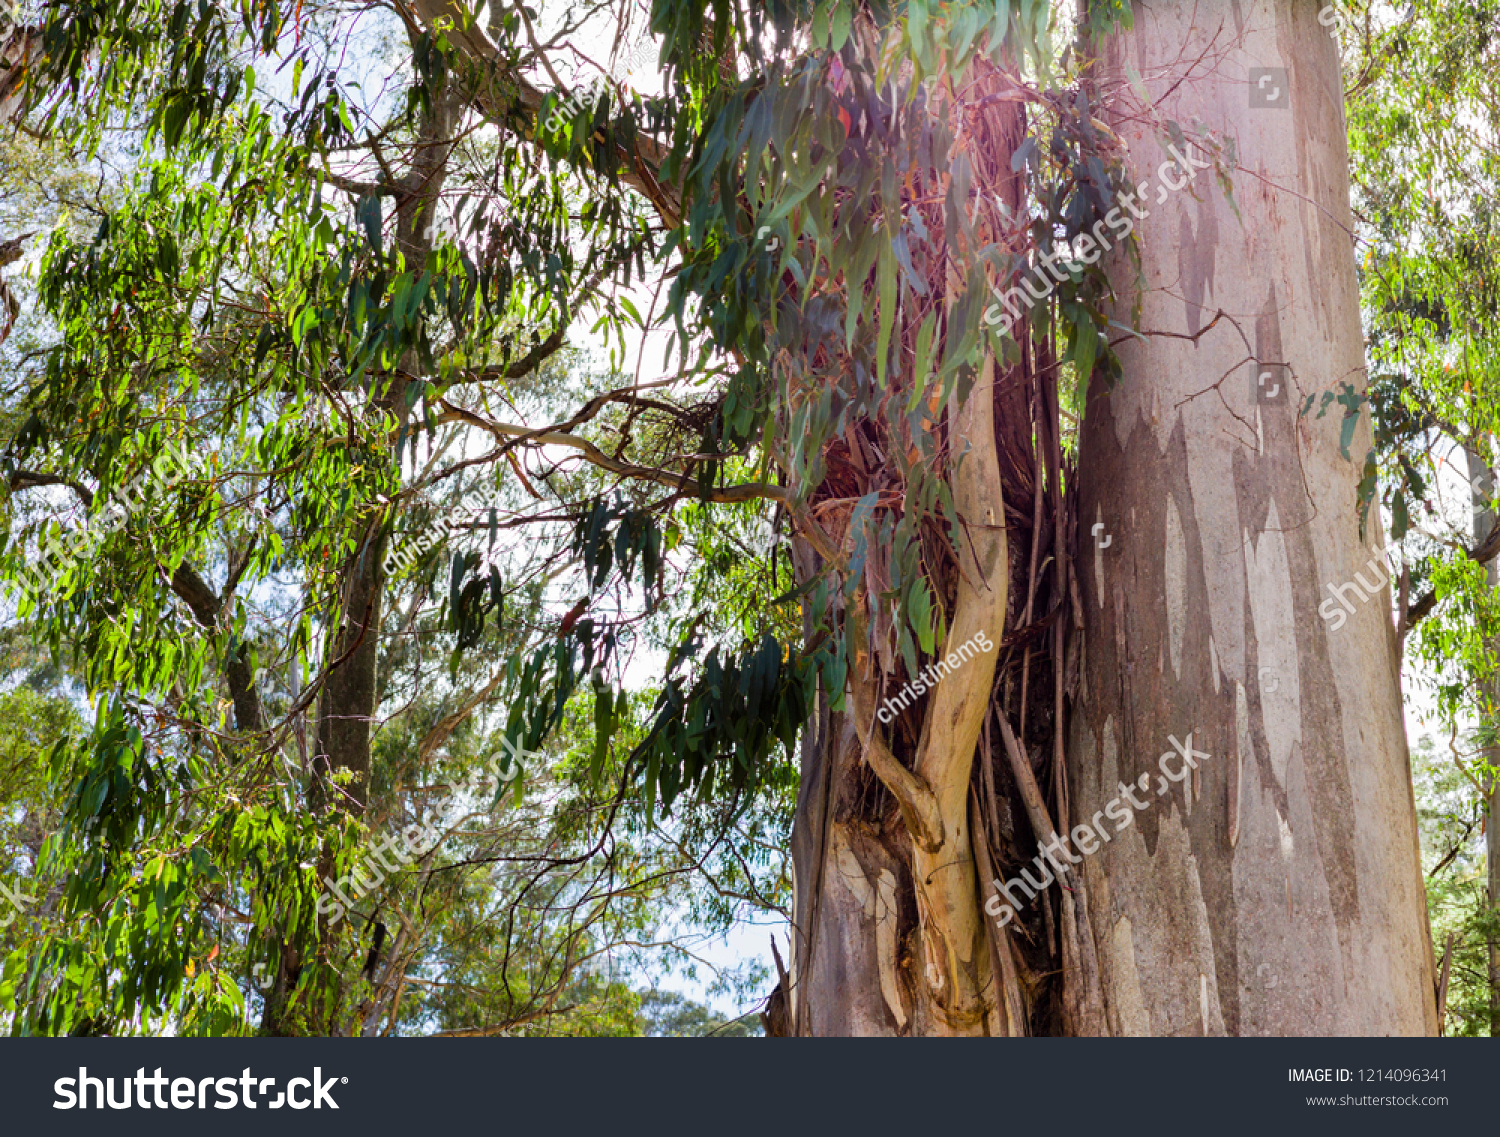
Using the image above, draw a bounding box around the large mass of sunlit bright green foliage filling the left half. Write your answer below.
[3,3,788,1034]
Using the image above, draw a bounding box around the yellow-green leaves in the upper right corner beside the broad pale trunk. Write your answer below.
[1341,0,1500,627]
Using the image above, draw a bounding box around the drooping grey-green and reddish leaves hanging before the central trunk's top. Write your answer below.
[656,3,1146,729]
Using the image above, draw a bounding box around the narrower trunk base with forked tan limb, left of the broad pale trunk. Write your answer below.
[789,336,1008,1035]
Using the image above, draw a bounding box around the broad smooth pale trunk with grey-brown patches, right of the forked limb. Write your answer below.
[1068,0,1437,1035]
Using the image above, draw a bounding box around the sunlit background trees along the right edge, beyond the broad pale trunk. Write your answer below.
[1340,2,1500,1034]
